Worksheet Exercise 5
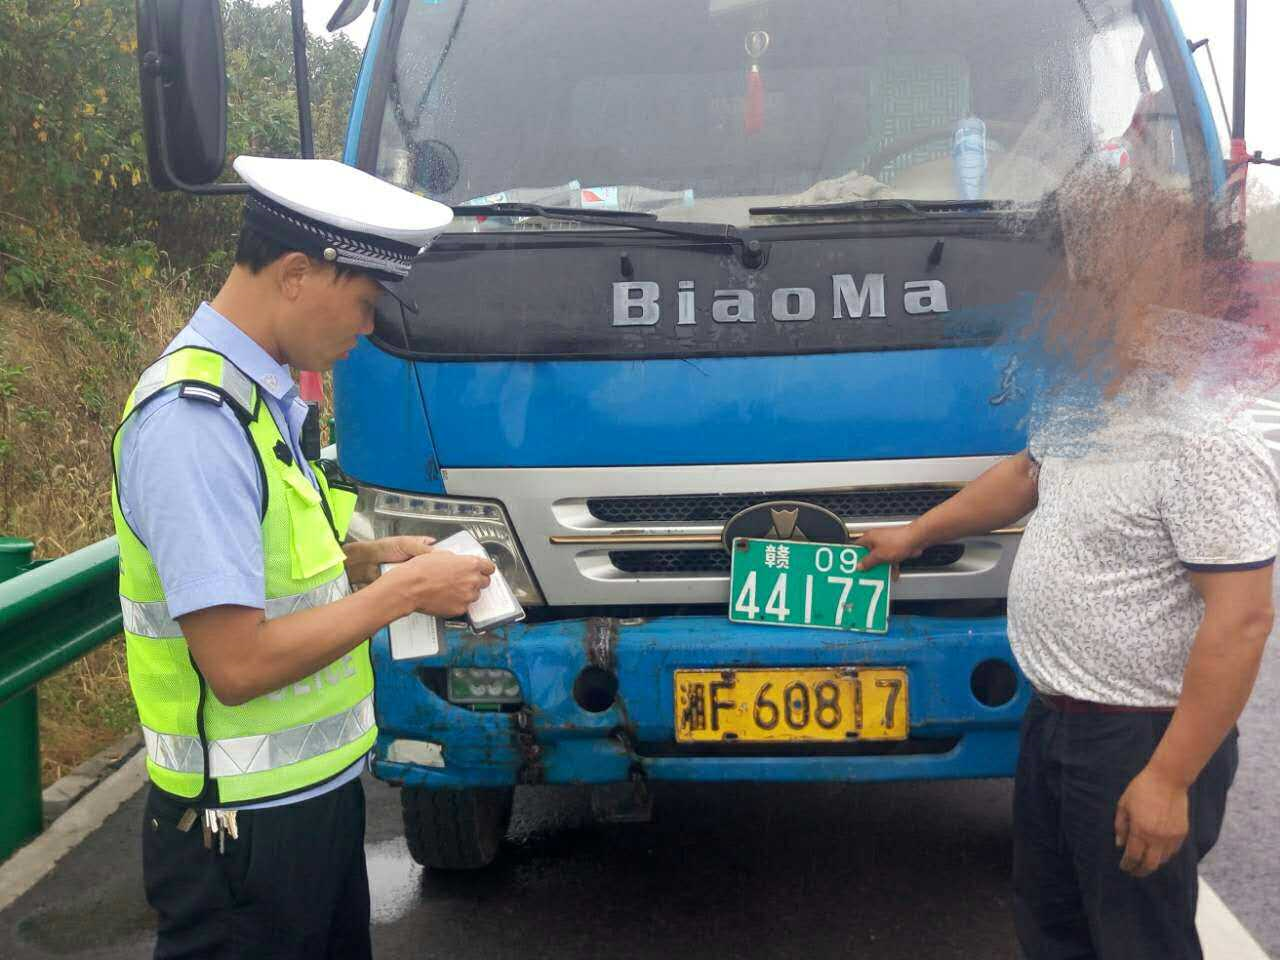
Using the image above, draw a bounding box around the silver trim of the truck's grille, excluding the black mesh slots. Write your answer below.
[442,457,1019,607]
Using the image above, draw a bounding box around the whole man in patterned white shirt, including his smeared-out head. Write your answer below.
[861,175,1280,960]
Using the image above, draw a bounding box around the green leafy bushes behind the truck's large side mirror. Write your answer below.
[0,0,360,327]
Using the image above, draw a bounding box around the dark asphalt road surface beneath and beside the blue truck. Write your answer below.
[0,627,1280,960]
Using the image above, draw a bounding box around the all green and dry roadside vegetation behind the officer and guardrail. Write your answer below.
[0,0,360,783]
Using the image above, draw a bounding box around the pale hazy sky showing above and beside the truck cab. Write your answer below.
[303,0,1280,193]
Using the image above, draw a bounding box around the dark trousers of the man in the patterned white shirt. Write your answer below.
[1014,698,1238,960]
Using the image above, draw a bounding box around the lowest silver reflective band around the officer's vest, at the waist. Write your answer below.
[142,696,374,777]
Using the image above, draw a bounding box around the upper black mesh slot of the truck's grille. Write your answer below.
[586,486,956,527]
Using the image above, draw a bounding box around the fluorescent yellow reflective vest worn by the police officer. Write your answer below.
[111,347,378,806]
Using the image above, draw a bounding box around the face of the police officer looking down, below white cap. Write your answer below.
[279,260,383,371]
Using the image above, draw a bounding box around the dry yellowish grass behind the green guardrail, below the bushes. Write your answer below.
[0,284,198,785]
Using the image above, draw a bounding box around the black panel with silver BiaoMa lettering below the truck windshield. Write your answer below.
[374,224,1059,361]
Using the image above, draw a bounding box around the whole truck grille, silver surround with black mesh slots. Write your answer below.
[443,456,1018,609]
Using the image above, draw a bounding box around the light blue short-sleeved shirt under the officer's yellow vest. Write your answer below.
[118,303,365,809]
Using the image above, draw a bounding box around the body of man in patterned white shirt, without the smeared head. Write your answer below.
[863,391,1280,960]
